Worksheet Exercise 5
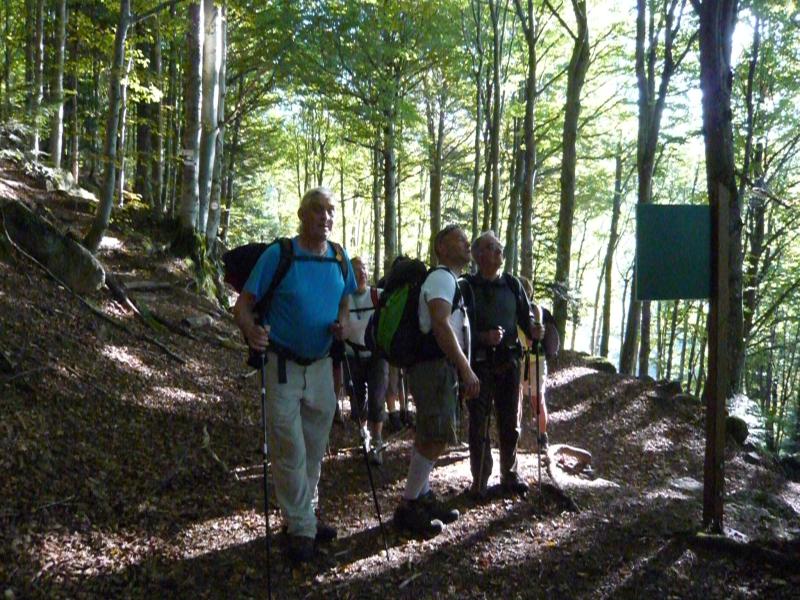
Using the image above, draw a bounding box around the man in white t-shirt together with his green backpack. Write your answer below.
[368,225,480,536]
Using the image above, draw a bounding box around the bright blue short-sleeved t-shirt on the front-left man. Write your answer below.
[244,237,356,358]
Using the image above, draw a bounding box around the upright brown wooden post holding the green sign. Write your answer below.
[703,184,730,533]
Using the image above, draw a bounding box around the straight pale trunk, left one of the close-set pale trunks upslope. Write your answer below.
[176,3,204,248]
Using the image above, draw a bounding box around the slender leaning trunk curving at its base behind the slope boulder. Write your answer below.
[83,0,131,252]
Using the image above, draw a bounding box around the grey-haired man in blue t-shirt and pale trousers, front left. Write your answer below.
[234,188,356,562]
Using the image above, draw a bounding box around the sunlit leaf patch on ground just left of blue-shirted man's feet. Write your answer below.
[175,511,260,559]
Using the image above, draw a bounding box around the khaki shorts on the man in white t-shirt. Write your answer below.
[408,358,458,444]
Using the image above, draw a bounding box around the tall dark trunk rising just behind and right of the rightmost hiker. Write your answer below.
[553,0,590,340]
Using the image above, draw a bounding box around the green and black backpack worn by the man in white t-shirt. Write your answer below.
[364,258,463,368]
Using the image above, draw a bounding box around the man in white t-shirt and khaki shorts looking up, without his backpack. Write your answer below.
[394,225,480,535]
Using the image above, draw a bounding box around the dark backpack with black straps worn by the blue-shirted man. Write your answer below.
[222,237,348,367]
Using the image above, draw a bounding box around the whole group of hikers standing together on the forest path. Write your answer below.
[234,188,547,562]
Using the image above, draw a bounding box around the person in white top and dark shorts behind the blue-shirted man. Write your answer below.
[345,256,389,465]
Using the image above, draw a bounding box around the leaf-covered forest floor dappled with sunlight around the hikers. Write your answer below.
[0,163,800,600]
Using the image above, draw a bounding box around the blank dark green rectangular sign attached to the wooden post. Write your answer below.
[636,204,711,300]
